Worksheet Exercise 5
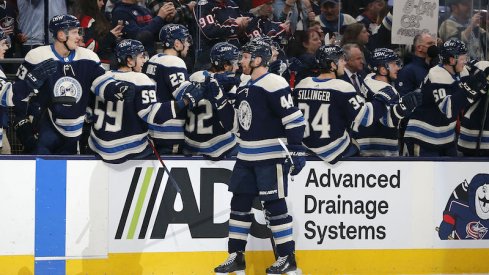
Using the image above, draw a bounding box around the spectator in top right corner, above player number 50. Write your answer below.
[438,0,486,60]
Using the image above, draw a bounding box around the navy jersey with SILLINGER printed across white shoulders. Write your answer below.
[294,77,375,162]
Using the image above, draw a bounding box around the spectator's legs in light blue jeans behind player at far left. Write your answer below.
[17,0,67,56]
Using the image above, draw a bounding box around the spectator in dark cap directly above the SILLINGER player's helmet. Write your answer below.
[315,0,356,37]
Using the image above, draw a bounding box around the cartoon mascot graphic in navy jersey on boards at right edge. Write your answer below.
[436,174,489,240]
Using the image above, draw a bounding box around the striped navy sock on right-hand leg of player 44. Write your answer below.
[264,199,295,257]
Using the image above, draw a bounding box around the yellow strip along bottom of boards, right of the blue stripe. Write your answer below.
[66,249,489,275]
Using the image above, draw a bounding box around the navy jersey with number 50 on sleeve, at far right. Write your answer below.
[404,65,469,149]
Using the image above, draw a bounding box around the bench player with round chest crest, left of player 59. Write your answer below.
[8,15,134,155]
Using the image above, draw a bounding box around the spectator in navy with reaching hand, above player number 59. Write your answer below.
[112,0,176,55]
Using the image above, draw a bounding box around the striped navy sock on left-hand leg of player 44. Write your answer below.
[228,194,254,253]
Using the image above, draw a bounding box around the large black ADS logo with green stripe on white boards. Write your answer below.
[115,167,270,239]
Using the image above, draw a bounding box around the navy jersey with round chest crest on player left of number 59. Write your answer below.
[11,46,115,139]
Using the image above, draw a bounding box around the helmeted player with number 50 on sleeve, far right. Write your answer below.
[404,40,486,156]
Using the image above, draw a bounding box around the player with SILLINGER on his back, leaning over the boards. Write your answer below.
[294,45,386,163]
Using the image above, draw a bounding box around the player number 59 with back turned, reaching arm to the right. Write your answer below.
[88,39,203,163]
